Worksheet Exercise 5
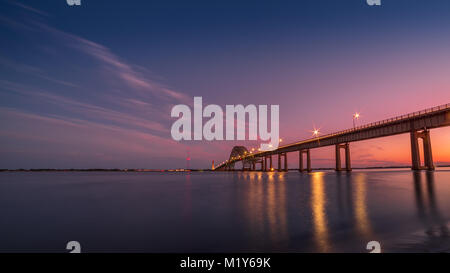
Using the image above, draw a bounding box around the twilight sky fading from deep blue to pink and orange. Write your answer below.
[0,0,450,169]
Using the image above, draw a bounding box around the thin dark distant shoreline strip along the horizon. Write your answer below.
[0,165,450,172]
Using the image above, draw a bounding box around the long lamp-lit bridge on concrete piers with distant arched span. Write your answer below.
[215,103,450,172]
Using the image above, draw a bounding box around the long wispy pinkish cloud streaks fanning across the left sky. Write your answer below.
[0,9,189,136]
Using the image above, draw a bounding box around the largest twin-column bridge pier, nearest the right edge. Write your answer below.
[410,129,435,171]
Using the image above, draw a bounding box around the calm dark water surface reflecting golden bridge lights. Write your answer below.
[0,169,450,252]
